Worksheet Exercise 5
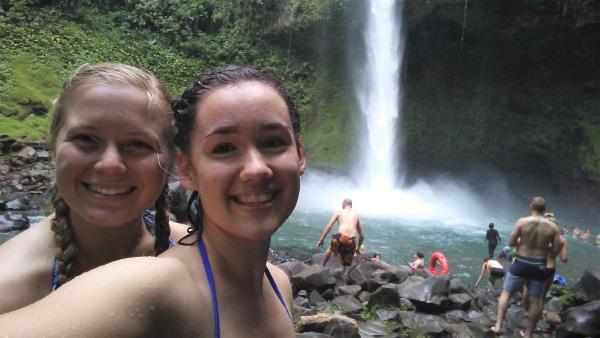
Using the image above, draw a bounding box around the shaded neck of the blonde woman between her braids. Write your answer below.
[71,213,154,274]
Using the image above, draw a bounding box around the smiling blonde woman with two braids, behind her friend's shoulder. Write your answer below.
[0,63,187,313]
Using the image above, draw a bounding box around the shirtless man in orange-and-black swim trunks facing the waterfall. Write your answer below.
[317,198,365,270]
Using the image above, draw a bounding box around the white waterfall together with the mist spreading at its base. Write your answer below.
[298,0,496,224]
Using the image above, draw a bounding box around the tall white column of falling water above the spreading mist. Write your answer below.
[355,0,404,191]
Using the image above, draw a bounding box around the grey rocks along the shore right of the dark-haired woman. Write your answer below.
[279,253,600,338]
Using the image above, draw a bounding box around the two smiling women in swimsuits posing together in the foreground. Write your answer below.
[0,63,306,337]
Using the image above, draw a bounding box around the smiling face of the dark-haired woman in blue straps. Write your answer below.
[178,81,305,240]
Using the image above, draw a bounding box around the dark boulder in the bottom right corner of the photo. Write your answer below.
[556,300,600,338]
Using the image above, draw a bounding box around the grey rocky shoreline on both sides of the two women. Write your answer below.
[0,136,600,338]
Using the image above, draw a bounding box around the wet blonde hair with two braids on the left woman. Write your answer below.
[49,63,175,285]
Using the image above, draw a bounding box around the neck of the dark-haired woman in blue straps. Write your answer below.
[202,226,271,295]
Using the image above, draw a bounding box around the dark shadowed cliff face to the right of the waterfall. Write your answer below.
[399,0,600,209]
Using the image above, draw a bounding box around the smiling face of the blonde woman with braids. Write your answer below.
[54,85,168,226]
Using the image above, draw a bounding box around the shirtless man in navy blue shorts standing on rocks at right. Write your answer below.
[490,197,562,338]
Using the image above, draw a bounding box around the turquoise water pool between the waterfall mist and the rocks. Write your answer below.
[271,211,600,286]
